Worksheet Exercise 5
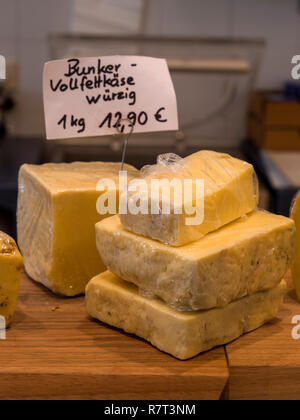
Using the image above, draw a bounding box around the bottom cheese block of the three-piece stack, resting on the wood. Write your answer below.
[86,271,286,360]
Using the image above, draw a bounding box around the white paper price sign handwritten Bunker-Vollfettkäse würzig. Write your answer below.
[43,56,178,140]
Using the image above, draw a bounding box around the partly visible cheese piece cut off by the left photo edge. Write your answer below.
[0,232,23,328]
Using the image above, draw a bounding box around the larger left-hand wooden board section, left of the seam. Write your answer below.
[0,275,228,400]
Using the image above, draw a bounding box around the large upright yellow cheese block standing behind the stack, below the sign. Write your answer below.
[17,162,138,296]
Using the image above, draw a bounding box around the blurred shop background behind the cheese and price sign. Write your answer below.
[0,0,300,236]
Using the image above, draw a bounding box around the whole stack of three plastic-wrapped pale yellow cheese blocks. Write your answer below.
[86,151,295,360]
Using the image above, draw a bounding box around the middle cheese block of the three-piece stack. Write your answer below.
[96,211,295,310]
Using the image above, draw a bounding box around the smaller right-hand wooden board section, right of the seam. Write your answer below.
[226,276,300,400]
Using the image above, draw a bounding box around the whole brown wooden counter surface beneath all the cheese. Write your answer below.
[0,275,300,400]
